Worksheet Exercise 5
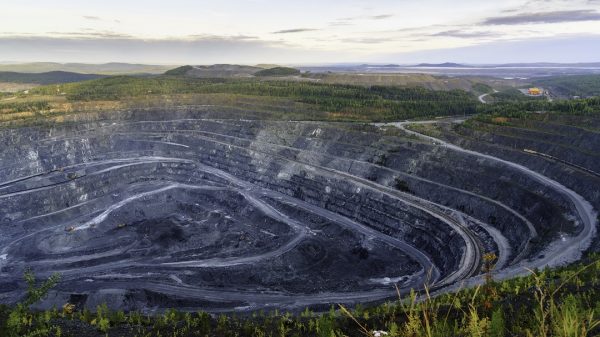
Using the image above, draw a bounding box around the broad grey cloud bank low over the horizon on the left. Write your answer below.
[0,33,338,64]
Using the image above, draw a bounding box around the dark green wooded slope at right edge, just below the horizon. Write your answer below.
[534,75,600,98]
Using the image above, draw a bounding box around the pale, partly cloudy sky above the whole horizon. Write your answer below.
[0,0,600,65]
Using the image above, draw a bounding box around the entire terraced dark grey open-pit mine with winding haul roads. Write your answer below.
[0,107,582,311]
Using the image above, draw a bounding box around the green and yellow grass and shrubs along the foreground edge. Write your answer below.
[0,255,600,337]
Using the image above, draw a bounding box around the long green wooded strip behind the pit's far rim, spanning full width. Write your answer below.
[7,75,600,126]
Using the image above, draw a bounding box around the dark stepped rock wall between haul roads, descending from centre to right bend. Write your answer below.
[199,150,464,273]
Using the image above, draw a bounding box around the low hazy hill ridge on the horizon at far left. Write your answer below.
[0,62,173,75]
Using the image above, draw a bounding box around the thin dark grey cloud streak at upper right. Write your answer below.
[482,9,600,25]
